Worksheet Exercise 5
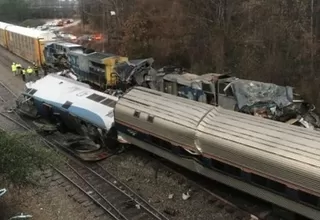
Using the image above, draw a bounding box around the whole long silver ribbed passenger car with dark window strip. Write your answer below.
[115,87,320,220]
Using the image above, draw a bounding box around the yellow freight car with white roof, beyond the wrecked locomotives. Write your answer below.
[0,22,56,66]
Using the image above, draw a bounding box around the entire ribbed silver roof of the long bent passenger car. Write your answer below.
[115,87,320,195]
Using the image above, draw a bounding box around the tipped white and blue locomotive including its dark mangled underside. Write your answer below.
[17,74,118,161]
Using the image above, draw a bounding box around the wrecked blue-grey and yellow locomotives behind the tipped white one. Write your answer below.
[44,42,156,91]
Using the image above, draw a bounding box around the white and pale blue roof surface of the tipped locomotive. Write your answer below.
[26,74,118,129]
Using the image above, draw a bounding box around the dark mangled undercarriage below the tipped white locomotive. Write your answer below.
[15,89,120,161]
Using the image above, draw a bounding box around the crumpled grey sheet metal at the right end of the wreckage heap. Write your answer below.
[230,80,320,129]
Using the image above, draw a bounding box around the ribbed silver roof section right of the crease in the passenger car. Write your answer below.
[199,108,320,194]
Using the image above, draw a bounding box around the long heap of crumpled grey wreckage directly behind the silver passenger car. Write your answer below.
[158,73,320,130]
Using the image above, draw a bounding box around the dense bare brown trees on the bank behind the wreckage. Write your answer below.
[80,0,320,109]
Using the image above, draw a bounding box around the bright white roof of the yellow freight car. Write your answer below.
[6,25,56,40]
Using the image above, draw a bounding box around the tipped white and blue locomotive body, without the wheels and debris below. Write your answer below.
[23,74,118,138]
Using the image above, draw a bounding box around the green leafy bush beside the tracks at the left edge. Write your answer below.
[0,132,61,184]
